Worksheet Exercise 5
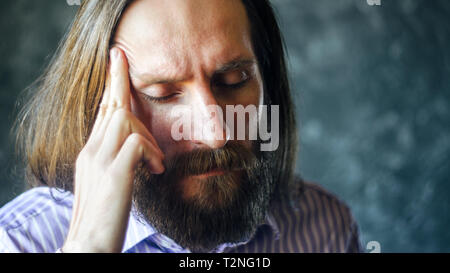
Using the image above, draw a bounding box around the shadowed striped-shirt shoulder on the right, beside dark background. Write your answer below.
[274,177,360,252]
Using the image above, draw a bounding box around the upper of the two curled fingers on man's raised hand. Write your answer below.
[99,109,164,160]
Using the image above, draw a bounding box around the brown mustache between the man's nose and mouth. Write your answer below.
[161,142,260,178]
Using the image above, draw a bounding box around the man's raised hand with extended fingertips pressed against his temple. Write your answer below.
[62,48,164,252]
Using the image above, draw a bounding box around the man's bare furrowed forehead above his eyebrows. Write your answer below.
[112,0,254,85]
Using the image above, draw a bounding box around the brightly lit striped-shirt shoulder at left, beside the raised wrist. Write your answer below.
[0,187,72,252]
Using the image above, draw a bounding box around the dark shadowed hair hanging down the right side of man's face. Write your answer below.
[242,0,302,203]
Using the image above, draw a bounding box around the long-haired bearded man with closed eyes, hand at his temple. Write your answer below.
[0,0,359,252]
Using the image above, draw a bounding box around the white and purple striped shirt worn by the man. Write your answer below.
[0,180,362,253]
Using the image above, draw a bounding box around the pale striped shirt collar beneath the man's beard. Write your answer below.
[122,206,280,252]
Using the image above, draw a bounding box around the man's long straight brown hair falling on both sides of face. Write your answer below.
[15,0,297,200]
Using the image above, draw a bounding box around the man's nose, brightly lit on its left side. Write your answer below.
[191,85,229,149]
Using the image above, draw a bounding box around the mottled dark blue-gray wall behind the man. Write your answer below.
[0,0,450,252]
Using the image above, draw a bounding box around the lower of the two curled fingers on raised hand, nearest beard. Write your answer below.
[111,134,165,177]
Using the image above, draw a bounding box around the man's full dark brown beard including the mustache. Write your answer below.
[133,141,275,252]
